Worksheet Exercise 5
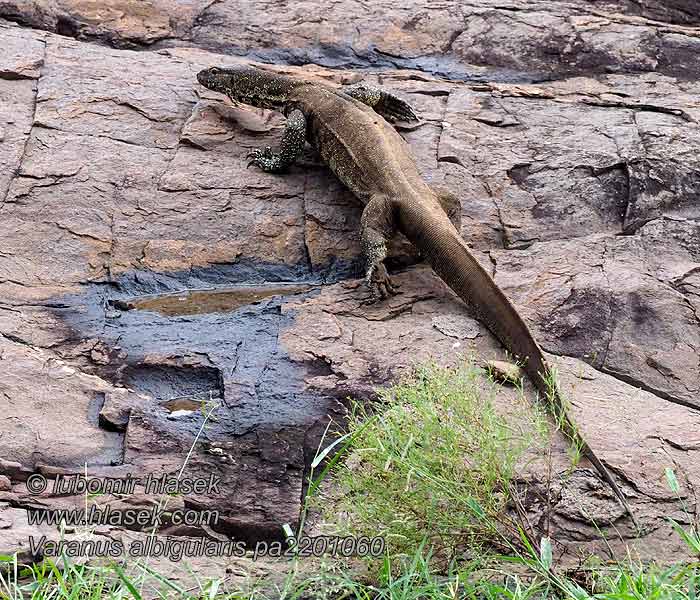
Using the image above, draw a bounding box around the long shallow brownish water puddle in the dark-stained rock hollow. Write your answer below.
[112,284,316,317]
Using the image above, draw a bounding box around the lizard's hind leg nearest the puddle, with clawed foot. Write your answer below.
[360,195,397,302]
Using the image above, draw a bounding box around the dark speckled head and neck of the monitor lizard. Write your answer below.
[197,67,300,108]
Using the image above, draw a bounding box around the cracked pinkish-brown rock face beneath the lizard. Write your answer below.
[0,0,700,559]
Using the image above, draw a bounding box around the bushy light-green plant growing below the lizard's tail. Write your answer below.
[321,363,542,561]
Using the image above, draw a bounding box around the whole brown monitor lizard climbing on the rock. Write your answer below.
[197,67,637,526]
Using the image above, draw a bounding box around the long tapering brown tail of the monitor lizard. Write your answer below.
[404,210,639,529]
